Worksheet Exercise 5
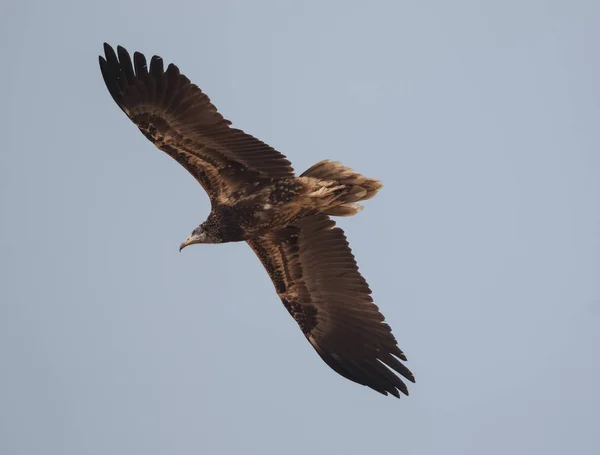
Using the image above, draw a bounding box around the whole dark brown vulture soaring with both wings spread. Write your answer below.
[99,44,414,398]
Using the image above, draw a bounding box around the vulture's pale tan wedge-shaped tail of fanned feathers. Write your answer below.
[300,160,382,216]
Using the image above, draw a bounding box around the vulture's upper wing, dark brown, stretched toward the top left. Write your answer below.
[100,43,294,199]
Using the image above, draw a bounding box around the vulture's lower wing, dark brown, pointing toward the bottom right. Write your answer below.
[248,214,414,397]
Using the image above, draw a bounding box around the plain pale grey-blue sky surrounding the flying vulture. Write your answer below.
[0,0,600,455]
